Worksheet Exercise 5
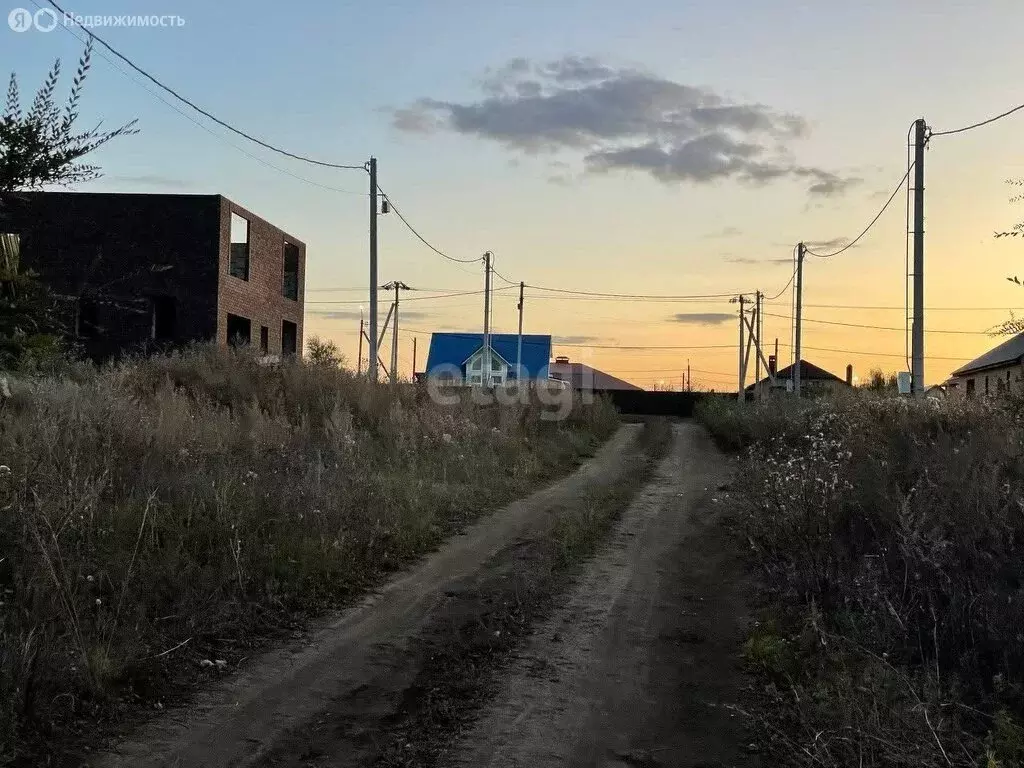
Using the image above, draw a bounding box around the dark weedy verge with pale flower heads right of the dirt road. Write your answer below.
[699,393,1024,768]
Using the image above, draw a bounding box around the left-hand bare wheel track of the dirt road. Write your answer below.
[90,425,641,768]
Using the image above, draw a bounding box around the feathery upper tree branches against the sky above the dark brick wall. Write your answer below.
[0,39,138,194]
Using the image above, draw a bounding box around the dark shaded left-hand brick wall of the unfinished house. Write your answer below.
[0,193,220,358]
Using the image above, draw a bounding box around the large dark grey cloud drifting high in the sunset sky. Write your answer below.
[392,56,860,198]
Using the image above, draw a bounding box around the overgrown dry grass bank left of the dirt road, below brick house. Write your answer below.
[0,348,617,765]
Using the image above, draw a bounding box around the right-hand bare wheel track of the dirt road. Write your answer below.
[450,424,754,768]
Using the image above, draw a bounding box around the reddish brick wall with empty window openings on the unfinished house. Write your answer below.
[217,198,306,354]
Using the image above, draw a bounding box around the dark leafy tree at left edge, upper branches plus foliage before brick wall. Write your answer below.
[0,40,137,368]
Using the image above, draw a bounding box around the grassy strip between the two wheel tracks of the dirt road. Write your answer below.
[372,420,672,768]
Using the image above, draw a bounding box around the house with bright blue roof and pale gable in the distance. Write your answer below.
[425,333,551,386]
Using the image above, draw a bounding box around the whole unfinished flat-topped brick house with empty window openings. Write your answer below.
[0,193,306,359]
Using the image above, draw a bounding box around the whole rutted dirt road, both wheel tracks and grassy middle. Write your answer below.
[90,424,752,768]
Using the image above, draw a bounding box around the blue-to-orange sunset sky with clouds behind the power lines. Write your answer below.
[8,0,1024,389]
